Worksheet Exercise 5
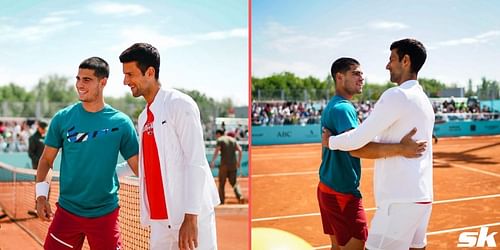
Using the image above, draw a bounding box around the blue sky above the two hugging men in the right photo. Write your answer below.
[252,0,500,90]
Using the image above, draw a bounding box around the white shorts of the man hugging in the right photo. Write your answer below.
[366,203,432,250]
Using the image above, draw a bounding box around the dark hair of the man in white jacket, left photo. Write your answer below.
[120,43,160,80]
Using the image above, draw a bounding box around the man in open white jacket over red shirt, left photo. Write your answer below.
[120,43,220,249]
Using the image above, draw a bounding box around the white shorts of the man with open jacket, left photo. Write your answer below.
[149,212,217,250]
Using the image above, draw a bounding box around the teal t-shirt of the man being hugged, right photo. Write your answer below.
[319,96,361,198]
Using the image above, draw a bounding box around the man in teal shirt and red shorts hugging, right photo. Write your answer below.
[317,58,425,249]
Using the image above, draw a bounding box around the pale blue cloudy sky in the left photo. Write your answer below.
[0,0,248,105]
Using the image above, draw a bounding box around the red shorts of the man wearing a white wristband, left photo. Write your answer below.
[43,204,122,250]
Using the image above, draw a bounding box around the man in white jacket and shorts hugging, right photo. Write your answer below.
[322,39,434,250]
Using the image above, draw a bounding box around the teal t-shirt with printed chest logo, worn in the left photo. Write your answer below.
[45,102,139,218]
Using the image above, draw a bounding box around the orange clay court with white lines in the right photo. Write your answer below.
[251,136,500,249]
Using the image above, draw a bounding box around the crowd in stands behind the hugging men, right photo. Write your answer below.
[252,98,498,126]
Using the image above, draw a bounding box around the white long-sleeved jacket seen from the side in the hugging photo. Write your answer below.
[329,80,434,205]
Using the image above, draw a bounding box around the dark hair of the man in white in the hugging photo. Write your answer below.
[391,38,427,73]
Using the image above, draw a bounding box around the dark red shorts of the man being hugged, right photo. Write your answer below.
[318,182,368,246]
